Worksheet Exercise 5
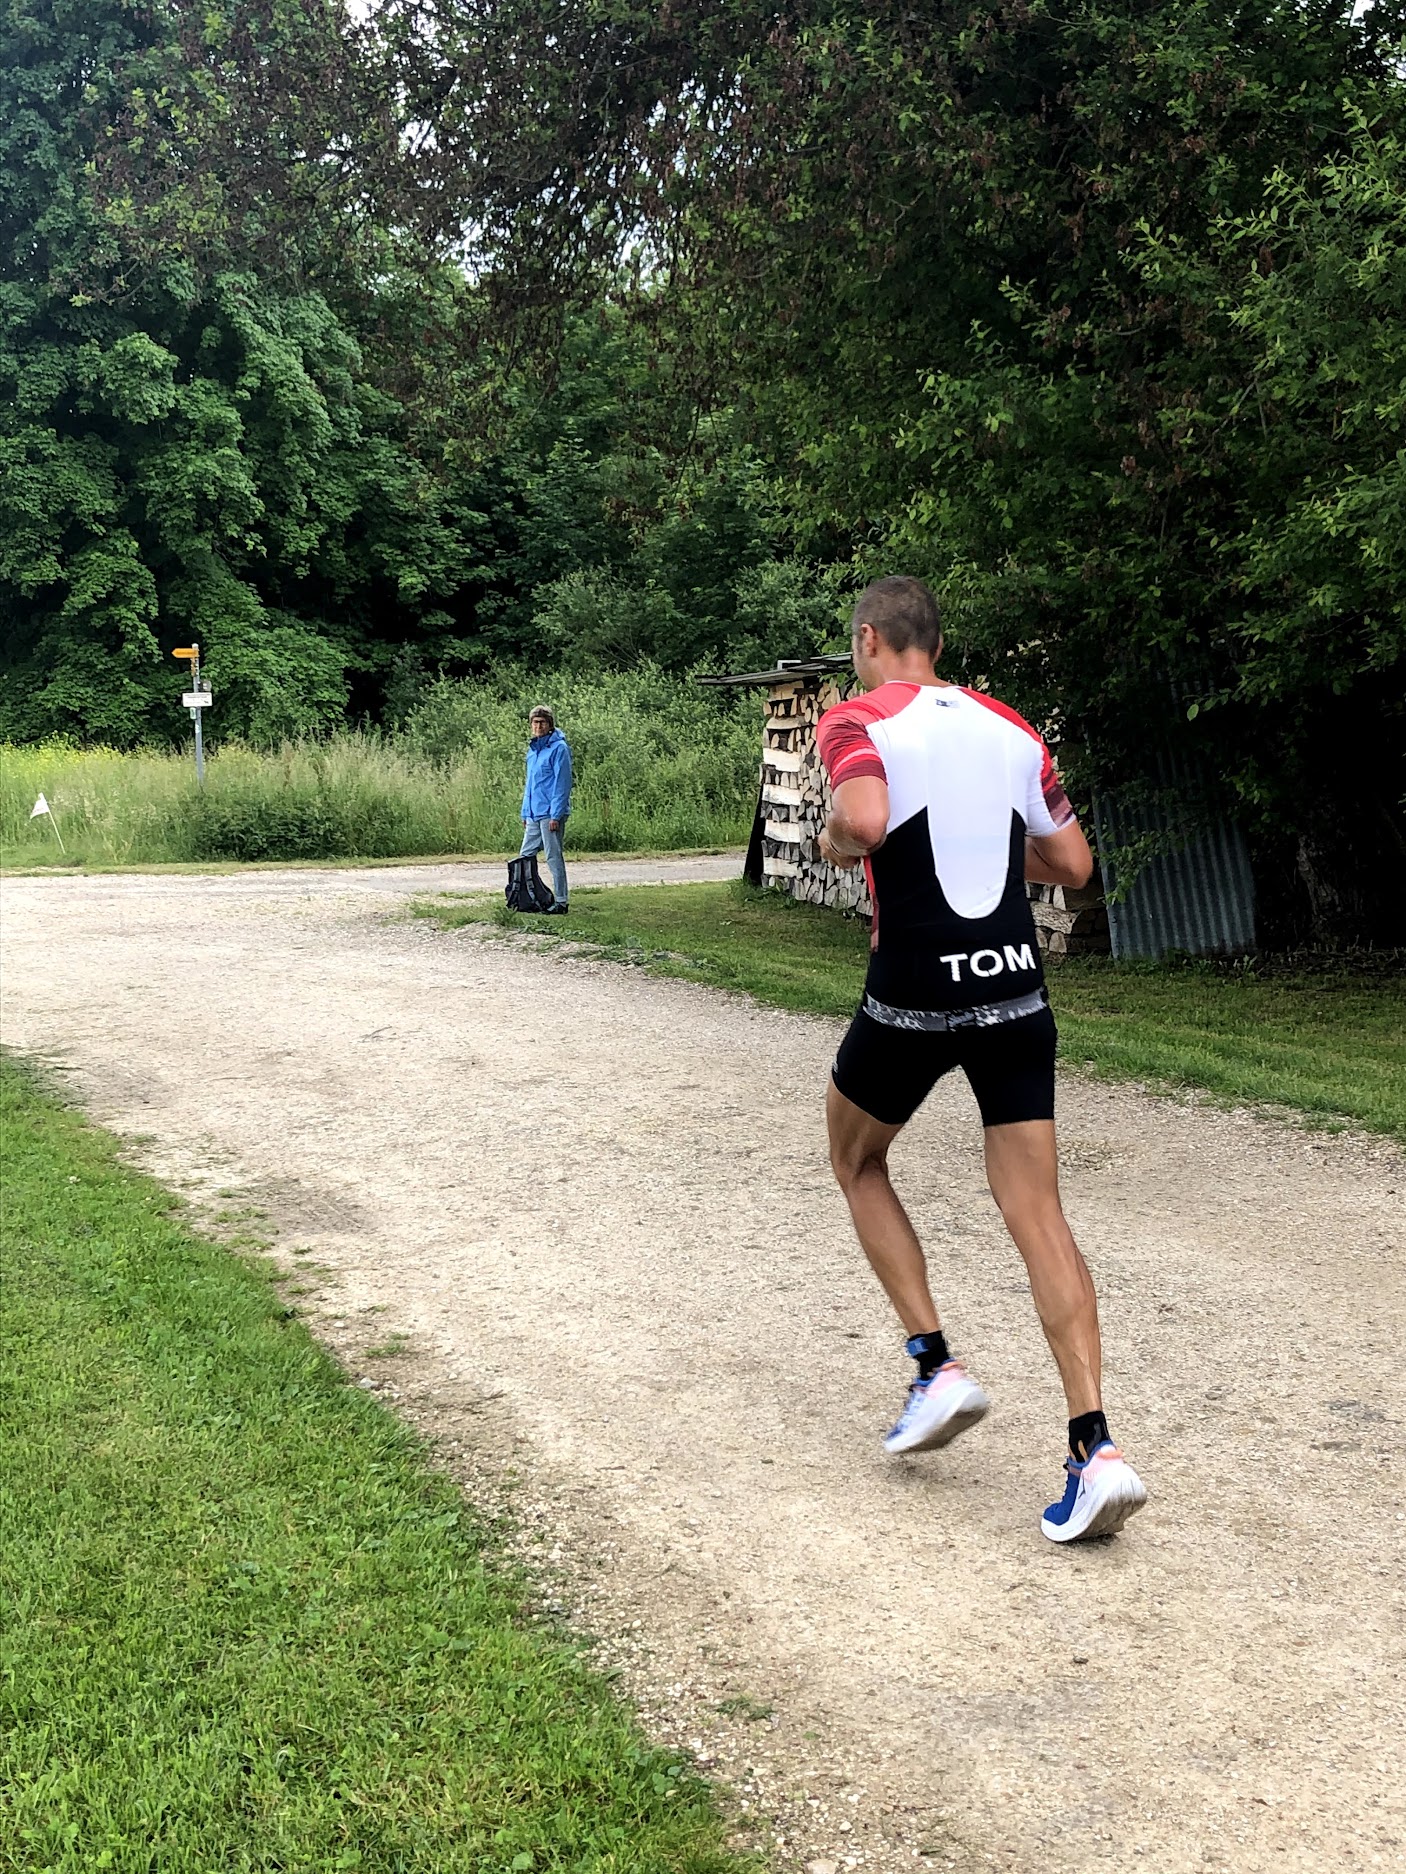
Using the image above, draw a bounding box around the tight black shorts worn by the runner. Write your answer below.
[832,1008,1055,1126]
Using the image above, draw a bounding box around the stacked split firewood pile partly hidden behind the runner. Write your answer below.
[761,675,1108,956]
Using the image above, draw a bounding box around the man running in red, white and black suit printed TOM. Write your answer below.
[819,579,1147,1542]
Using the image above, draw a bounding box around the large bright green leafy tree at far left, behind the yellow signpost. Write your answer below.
[0,0,469,744]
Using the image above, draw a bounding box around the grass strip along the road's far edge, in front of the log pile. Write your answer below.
[416,885,1406,1139]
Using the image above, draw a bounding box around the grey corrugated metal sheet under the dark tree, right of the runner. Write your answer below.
[1095,791,1254,958]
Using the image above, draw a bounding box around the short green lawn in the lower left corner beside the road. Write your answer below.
[0,1063,750,1874]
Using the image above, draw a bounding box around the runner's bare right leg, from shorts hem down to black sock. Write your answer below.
[986,1119,1102,1419]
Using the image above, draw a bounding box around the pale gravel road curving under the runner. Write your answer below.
[4,868,1406,1874]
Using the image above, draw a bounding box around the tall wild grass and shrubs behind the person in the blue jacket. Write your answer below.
[0,667,759,866]
